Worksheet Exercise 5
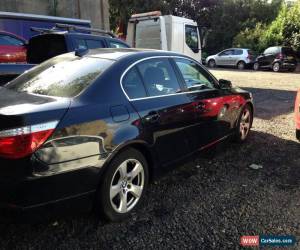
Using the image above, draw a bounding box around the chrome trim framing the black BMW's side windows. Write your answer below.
[120,56,218,102]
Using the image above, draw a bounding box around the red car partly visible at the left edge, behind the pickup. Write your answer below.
[0,31,27,63]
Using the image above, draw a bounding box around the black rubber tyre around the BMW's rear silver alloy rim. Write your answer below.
[96,148,149,221]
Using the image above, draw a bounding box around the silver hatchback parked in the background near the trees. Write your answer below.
[206,48,254,69]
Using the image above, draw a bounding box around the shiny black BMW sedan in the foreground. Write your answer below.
[0,49,253,221]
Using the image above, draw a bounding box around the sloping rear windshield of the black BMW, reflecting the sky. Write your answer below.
[5,53,113,97]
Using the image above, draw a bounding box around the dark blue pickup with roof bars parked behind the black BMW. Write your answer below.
[0,25,129,86]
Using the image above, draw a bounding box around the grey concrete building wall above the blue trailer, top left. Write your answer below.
[0,0,109,30]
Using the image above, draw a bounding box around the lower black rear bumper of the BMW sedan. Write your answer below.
[0,167,99,223]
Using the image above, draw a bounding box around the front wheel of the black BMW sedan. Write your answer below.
[234,104,253,142]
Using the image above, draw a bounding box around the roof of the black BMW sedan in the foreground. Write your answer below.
[85,48,186,61]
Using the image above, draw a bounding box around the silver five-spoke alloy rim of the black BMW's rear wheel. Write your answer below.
[109,159,145,213]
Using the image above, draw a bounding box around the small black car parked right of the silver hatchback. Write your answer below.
[253,46,297,72]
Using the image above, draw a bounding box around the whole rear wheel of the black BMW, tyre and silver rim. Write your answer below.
[97,148,149,221]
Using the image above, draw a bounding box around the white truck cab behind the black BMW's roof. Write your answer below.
[126,11,201,63]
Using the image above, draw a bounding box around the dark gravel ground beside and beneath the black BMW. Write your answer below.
[0,69,300,250]
